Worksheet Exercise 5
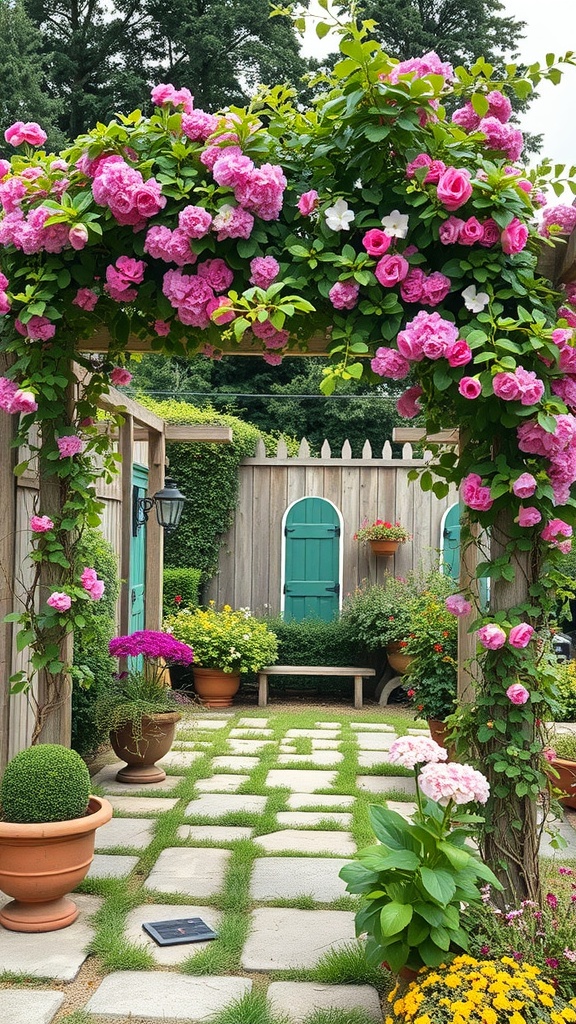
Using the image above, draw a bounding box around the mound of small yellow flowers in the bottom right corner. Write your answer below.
[384,955,576,1024]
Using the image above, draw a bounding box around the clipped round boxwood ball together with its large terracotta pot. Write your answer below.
[0,743,112,932]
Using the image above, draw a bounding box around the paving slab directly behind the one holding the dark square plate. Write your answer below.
[146,847,232,899]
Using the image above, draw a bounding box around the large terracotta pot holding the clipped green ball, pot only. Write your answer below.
[0,797,112,932]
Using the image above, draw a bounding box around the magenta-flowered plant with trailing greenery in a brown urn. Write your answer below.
[96,630,194,785]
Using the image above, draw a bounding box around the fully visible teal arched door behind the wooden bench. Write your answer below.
[282,498,341,622]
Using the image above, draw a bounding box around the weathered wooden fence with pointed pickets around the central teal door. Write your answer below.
[205,440,457,614]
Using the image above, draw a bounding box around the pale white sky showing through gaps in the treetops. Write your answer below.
[302,0,576,182]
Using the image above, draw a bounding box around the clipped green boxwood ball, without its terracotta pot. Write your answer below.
[0,743,90,824]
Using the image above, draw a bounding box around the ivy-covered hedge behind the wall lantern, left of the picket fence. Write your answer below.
[138,396,296,583]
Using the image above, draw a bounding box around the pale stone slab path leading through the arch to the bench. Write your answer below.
[0,709,576,1024]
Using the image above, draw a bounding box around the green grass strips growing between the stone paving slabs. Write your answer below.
[71,709,413,1003]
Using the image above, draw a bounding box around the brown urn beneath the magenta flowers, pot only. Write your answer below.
[110,711,180,785]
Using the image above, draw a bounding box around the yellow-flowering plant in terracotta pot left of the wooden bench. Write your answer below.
[164,601,278,708]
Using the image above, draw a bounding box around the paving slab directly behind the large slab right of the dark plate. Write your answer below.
[250,857,349,903]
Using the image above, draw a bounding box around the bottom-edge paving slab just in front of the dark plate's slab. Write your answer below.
[85,971,252,1024]
